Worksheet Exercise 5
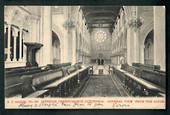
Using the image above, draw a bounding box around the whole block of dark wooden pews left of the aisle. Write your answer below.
[5,63,88,98]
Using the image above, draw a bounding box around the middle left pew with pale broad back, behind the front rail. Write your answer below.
[21,69,64,97]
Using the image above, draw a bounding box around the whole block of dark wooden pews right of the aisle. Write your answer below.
[112,63,166,97]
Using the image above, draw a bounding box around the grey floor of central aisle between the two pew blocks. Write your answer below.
[80,75,128,97]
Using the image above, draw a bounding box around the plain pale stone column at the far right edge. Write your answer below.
[154,6,166,71]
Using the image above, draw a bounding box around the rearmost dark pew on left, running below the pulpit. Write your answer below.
[5,63,71,97]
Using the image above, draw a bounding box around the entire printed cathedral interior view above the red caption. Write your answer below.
[4,5,166,98]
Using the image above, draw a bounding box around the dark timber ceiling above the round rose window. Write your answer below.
[81,6,121,29]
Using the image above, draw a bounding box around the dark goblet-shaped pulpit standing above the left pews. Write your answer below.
[24,42,43,67]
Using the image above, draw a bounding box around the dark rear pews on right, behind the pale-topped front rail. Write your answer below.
[121,63,166,89]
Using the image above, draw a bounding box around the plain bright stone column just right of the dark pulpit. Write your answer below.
[42,6,52,65]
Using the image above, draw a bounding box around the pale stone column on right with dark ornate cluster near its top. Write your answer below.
[127,6,142,65]
